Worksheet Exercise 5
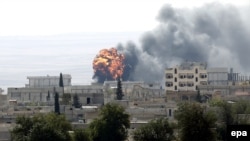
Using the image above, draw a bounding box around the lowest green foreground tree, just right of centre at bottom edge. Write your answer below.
[133,118,174,141]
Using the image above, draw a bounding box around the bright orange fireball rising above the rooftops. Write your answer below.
[93,48,125,79]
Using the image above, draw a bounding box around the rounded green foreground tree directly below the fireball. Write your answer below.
[89,103,130,141]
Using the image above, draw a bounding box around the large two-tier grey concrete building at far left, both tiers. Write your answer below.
[7,74,71,104]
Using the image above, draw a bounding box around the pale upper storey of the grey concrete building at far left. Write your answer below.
[25,74,71,88]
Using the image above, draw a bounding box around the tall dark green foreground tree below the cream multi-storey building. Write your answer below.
[175,103,216,141]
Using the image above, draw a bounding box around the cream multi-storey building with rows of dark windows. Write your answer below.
[165,62,208,91]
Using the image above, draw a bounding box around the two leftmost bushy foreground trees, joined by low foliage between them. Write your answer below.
[11,103,130,141]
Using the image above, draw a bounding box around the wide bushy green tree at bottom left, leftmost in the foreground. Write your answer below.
[10,113,72,141]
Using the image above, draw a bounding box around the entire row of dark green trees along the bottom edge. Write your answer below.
[11,100,250,141]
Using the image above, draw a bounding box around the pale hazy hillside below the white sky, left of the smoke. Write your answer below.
[0,32,141,94]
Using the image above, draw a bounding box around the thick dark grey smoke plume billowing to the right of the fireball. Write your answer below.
[117,3,250,82]
